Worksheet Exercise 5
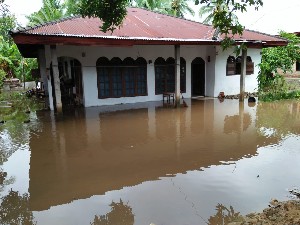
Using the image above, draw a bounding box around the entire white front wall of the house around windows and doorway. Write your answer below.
[51,45,260,107]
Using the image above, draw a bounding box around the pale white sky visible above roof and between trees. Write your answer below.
[5,0,300,34]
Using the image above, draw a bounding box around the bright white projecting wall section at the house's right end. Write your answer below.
[213,47,261,97]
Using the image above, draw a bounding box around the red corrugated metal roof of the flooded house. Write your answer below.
[12,8,287,57]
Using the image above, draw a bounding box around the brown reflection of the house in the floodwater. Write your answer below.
[29,100,257,211]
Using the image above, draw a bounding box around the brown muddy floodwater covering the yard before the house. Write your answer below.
[0,99,300,225]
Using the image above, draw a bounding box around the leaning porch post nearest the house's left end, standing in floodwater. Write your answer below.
[51,45,62,113]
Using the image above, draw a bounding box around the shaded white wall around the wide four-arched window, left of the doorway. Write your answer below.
[57,45,206,107]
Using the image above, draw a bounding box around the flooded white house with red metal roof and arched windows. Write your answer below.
[11,8,287,110]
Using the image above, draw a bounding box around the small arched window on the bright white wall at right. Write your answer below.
[226,56,254,76]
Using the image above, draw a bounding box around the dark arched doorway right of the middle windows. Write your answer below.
[192,57,205,96]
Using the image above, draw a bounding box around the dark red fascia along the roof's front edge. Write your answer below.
[11,32,288,57]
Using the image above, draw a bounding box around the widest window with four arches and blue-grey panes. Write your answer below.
[97,57,147,98]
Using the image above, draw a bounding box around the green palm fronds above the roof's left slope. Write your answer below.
[26,0,65,26]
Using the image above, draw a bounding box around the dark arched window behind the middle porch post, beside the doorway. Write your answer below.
[154,57,186,95]
